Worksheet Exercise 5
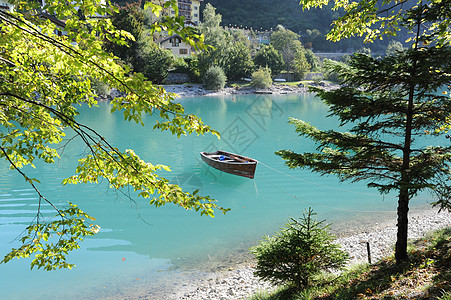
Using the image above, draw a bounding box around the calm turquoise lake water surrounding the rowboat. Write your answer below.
[0,94,438,299]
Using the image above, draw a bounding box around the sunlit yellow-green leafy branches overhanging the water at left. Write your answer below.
[0,1,227,270]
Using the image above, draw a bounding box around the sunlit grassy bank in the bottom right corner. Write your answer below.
[249,227,451,300]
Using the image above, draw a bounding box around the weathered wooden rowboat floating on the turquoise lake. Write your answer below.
[200,151,257,178]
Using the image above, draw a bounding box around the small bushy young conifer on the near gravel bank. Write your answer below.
[251,208,348,289]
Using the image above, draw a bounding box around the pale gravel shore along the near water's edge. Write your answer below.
[177,209,451,300]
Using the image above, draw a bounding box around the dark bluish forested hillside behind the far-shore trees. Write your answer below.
[201,0,402,52]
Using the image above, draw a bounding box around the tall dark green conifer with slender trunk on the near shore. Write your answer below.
[277,1,451,262]
